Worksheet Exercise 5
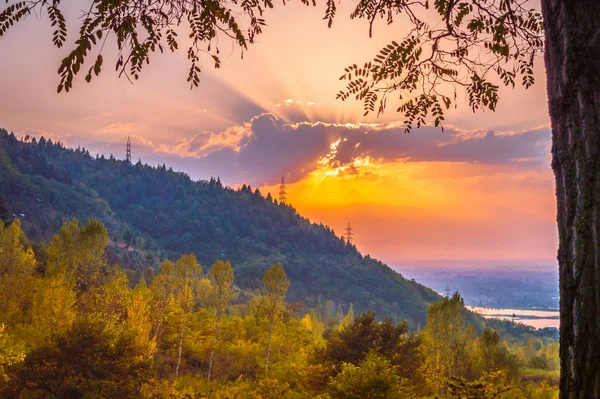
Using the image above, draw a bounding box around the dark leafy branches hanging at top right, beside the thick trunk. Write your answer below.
[337,0,543,132]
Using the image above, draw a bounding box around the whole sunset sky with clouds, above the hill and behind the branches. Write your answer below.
[0,1,557,267]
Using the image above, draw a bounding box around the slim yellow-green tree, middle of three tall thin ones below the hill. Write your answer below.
[207,260,233,381]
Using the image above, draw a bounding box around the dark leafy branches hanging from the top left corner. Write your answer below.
[0,0,314,92]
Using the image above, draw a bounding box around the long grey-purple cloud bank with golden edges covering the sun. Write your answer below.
[106,114,550,185]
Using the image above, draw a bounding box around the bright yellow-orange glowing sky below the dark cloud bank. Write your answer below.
[261,162,556,263]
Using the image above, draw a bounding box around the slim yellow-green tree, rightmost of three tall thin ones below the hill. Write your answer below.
[263,263,290,374]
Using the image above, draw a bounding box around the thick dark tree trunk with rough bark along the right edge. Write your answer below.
[542,0,600,399]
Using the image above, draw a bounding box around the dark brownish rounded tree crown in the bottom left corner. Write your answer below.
[3,319,151,398]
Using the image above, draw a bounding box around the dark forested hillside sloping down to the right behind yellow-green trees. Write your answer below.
[0,130,439,326]
